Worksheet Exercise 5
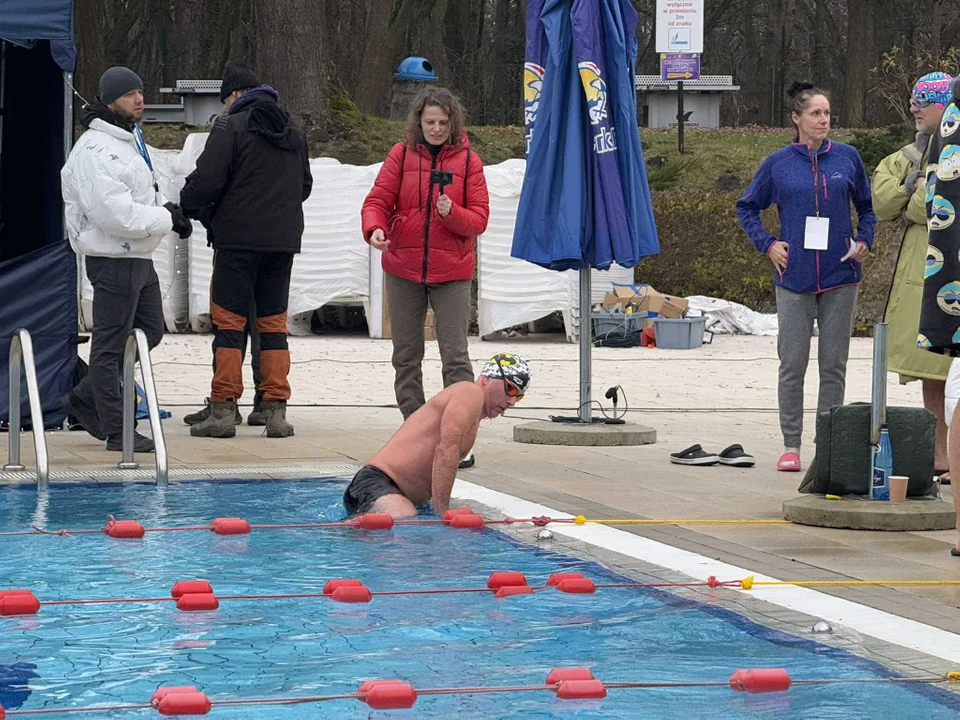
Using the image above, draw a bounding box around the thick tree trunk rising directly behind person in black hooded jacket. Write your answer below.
[254,0,329,129]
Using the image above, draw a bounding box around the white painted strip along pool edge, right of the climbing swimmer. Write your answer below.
[453,478,960,663]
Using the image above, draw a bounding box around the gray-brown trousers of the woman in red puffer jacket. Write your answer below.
[383,273,474,420]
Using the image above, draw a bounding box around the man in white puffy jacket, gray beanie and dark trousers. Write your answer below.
[60,67,193,452]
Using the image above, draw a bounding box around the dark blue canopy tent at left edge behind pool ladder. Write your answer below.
[0,0,78,427]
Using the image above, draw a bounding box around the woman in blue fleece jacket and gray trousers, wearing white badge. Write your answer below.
[737,83,876,472]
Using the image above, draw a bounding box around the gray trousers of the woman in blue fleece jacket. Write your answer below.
[777,286,859,448]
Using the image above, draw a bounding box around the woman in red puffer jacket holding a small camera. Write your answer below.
[361,87,490,438]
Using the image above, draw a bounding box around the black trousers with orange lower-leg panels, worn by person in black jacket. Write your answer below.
[210,250,293,402]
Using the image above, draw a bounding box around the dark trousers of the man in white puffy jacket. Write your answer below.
[73,256,163,435]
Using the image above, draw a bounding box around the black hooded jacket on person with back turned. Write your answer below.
[180,88,313,253]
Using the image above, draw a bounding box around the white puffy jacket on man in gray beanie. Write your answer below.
[60,118,173,258]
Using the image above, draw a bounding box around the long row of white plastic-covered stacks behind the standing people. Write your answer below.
[99,133,633,340]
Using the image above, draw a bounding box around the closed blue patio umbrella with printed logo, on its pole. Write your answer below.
[511,0,660,422]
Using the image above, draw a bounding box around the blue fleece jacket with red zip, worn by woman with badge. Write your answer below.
[737,140,877,293]
